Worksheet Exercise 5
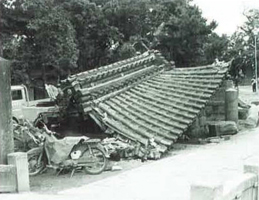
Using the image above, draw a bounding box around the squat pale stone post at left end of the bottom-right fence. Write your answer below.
[190,182,223,200]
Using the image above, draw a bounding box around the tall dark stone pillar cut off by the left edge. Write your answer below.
[0,57,14,164]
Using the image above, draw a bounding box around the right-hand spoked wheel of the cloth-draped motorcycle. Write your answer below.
[80,147,107,175]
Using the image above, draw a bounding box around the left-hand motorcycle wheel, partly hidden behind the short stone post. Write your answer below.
[27,148,45,176]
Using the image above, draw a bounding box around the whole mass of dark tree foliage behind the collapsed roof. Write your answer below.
[1,0,231,87]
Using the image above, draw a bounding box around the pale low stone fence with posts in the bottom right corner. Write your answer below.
[190,160,259,200]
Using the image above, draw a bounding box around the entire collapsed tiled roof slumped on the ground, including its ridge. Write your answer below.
[64,51,231,152]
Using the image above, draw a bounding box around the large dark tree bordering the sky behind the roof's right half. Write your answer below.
[102,0,219,67]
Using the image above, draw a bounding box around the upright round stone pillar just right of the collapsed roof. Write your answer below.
[225,88,238,123]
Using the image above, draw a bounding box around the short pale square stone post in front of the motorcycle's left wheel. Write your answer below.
[8,152,30,192]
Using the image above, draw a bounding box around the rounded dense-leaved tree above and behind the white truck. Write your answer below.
[27,4,78,77]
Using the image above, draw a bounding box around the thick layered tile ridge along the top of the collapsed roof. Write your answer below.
[60,50,171,116]
